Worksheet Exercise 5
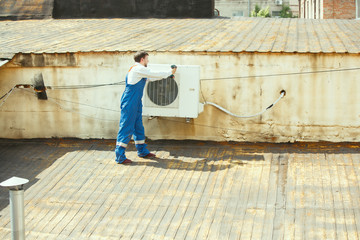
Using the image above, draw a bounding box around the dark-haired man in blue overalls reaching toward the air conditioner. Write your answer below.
[115,51,176,164]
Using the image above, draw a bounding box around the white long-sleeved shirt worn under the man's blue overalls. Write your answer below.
[128,62,172,85]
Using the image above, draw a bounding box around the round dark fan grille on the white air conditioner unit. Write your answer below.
[147,77,179,106]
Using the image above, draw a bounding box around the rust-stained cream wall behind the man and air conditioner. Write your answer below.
[0,52,360,142]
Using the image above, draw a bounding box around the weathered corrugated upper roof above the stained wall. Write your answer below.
[0,18,360,53]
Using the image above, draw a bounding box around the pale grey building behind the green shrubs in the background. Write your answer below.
[215,0,299,17]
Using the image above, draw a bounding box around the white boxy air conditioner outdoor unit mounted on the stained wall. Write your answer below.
[143,64,203,118]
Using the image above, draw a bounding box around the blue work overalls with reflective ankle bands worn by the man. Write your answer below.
[115,69,150,163]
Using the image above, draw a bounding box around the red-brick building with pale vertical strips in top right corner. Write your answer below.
[299,0,360,19]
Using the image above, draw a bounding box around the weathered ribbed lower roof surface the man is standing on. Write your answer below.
[0,140,360,240]
